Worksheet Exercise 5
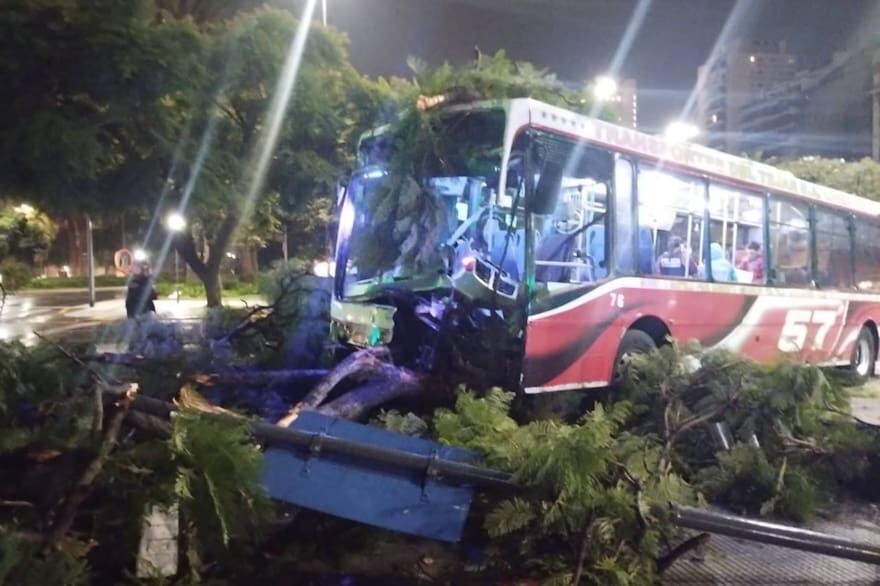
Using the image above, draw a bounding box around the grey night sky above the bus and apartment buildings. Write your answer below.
[300,0,880,131]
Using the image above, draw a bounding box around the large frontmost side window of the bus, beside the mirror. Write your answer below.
[533,136,613,283]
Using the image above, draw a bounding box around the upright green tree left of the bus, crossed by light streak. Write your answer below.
[168,9,378,306]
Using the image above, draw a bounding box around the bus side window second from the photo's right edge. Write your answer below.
[816,209,853,289]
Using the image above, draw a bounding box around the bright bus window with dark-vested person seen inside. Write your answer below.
[638,166,706,279]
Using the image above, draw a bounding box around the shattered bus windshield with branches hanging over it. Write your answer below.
[336,110,505,297]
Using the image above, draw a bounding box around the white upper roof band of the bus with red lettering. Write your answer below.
[511,98,880,216]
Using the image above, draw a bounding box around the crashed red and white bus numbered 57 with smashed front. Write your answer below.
[333,99,880,393]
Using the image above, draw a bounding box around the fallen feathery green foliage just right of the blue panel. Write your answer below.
[434,389,696,584]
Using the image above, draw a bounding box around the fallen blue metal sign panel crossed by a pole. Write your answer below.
[263,412,476,541]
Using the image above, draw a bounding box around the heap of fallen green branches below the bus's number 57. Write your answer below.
[622,343,880,520]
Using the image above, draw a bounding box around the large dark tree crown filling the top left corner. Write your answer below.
[0,0,204,272]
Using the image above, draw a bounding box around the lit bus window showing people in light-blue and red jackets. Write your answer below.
[709,182,766,283]
